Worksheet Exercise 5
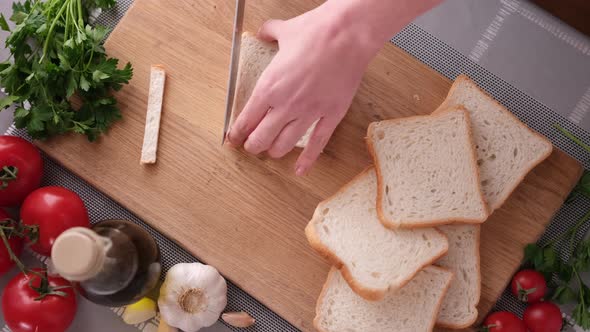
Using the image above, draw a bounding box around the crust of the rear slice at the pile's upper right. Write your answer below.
[432,74,553,213]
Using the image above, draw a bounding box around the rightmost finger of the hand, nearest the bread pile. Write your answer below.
[295,117,340,176]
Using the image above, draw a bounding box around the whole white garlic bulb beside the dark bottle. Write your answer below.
[158,263,227,332]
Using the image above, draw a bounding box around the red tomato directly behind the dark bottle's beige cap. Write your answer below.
[20,187,90,256]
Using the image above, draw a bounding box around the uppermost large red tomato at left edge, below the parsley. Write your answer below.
[0,136,43,206]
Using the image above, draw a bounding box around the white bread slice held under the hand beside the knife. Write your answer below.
[232,32,317,148]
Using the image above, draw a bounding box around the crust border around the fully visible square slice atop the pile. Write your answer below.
[365,106,490,229]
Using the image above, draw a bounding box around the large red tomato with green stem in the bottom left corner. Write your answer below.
[2,269,77,332]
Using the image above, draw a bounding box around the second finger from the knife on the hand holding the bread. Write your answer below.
[244,108,291,155]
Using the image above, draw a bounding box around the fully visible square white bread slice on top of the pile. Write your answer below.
[367,107,488,228]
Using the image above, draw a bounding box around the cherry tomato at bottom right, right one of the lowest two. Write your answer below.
[523,302,563,332]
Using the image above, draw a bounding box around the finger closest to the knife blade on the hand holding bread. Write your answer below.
[227,88,270,147]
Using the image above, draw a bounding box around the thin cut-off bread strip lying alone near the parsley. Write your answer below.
[140,65,166,164]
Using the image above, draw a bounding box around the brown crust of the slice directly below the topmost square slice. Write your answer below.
[305,166,449,301]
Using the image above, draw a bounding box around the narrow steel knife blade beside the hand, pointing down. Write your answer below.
[221,0,246,145]
